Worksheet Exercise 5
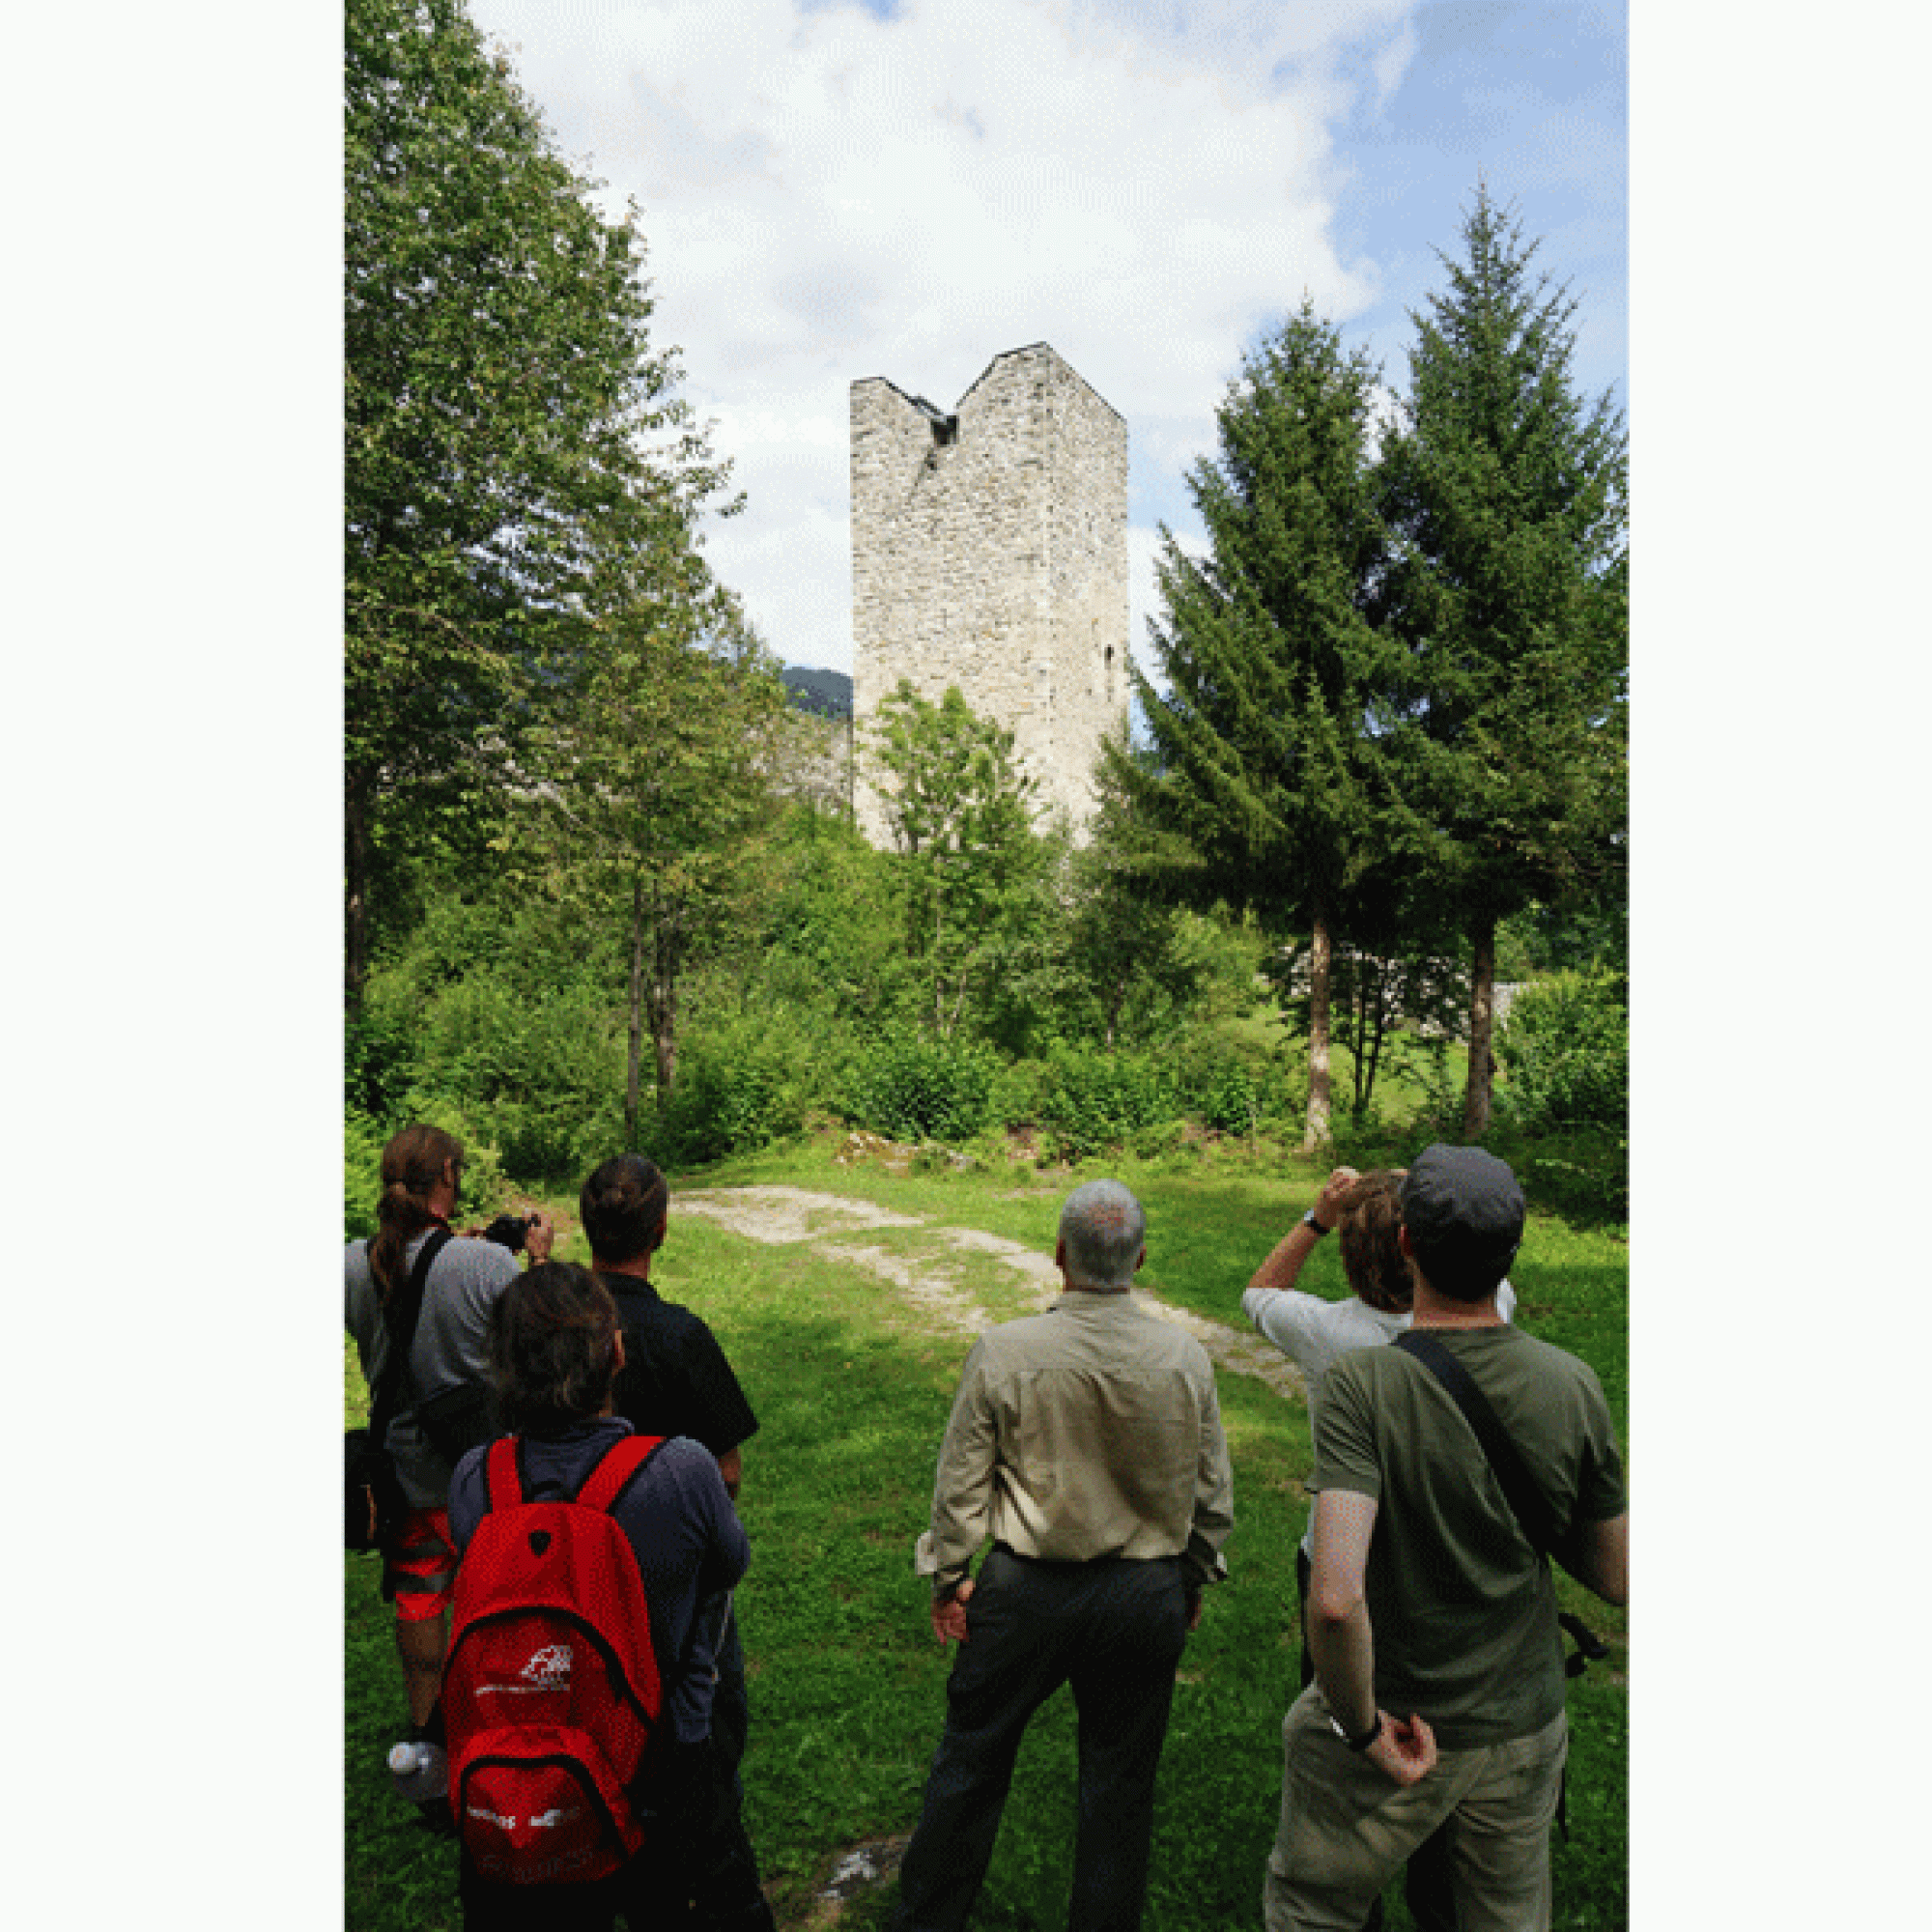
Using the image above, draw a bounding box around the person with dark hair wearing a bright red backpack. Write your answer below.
[442,1262,750,1932]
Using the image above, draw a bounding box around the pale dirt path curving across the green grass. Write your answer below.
[674,1188,1306,1397]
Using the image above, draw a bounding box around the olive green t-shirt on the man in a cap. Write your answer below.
[1308,1327,1627,1750]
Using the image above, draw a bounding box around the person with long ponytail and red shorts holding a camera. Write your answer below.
[344,1124,554,1828]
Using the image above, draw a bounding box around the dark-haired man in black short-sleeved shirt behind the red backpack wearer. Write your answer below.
[578,1153,773,1932]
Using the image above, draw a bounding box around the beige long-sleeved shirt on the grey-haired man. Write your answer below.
[914,1289,1235,1590]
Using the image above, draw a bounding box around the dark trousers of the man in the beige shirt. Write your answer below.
[893,1548,1188,1932]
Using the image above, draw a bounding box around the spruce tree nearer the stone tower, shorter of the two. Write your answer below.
[1115,301,1391,1144]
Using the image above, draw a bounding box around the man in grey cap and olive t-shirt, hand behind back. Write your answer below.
[1264,1146,1629,1932]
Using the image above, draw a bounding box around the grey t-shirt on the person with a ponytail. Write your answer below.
[342,1229,518,1509]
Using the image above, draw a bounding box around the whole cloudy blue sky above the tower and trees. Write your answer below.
[460,0,1629,670]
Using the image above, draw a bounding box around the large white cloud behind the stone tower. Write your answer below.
[473,0,1410,668]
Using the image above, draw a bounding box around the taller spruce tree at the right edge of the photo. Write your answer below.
[1379,185,1629,1140]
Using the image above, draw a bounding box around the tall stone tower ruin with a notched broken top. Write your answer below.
[852,342,1128,844]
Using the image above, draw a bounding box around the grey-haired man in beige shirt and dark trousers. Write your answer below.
[893,1180,1235,1932]
